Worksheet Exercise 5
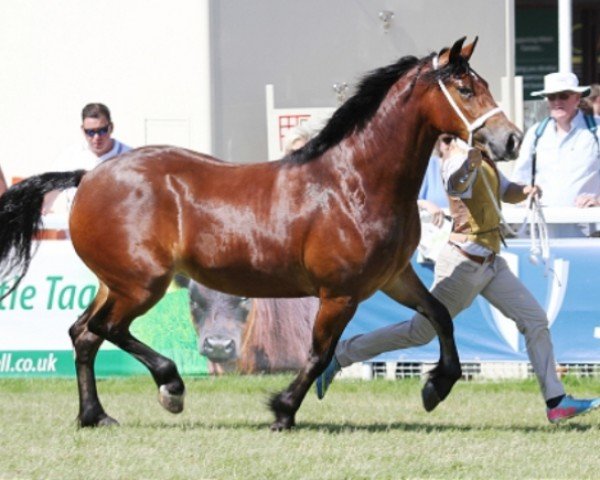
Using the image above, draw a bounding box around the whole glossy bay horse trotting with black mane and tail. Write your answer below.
[0,38,521,430]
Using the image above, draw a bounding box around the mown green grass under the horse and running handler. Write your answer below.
[0,376,600,480]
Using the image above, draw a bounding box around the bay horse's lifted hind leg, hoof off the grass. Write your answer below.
[89,280,185,413]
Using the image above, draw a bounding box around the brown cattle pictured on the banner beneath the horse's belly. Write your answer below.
[184,275,319,375]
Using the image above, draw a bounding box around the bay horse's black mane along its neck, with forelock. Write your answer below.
[288,49,468,163]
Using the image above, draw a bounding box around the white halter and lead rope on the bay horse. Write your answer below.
[432,55,550,275]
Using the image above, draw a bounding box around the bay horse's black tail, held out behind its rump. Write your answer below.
[0,170,86,300]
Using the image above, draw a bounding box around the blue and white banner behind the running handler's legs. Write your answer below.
[343,238,600,363]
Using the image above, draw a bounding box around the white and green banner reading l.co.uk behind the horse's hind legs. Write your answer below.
[0,240,207,377]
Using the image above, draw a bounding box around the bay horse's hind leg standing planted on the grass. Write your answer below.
[69,285,117,427]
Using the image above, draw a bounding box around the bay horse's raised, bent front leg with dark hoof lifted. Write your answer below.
[382,264,462,412]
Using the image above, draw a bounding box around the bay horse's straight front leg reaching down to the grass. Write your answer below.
[270,296,358,431]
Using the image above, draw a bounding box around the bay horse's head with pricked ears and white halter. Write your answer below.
[430,38,522,161]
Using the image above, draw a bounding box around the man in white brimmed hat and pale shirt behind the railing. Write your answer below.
[512,72,600,237]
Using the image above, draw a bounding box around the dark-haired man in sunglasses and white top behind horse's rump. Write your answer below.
[43,103,131,213]
